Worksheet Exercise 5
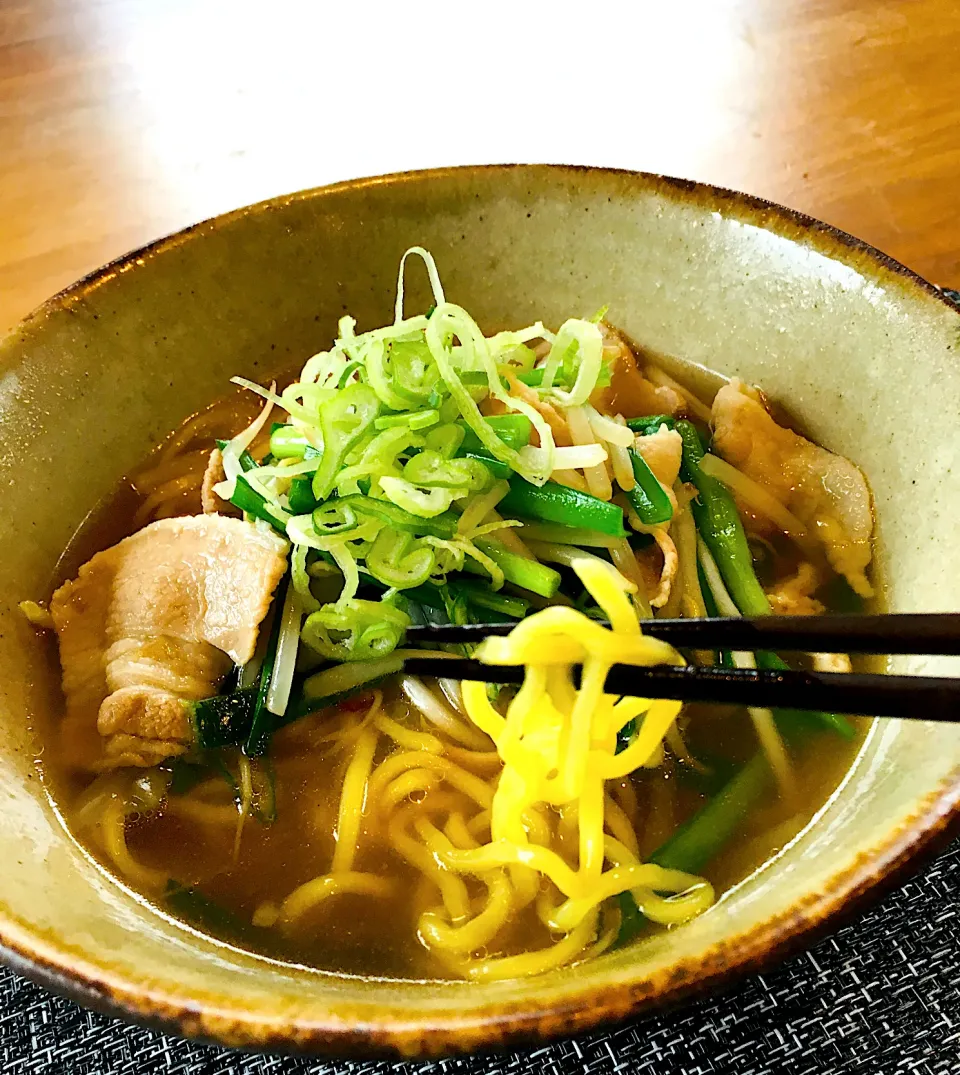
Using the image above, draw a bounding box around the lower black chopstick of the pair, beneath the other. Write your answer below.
[403,657,960,723]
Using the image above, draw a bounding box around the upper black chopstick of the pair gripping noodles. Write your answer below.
[406,613,960,653]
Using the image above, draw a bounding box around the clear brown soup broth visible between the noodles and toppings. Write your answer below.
[41,382,868,978]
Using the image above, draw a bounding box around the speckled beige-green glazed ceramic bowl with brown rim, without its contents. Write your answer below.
[0,167,960,1056]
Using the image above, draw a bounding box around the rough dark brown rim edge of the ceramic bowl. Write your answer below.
[0,163,960,1058]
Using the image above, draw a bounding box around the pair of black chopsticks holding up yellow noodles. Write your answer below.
[404,613,960,723]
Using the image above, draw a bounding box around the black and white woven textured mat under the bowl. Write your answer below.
[0,291,960,1075]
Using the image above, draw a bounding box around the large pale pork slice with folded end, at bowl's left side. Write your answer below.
[51,515,287,769]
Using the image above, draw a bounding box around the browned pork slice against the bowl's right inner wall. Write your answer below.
[713,381,873,597]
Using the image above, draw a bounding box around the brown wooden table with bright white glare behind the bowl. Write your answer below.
[0,0,960,329]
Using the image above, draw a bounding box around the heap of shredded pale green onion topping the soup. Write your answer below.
[217,246,632,675]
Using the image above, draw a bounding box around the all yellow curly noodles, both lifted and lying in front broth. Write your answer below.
[247,557,714,980]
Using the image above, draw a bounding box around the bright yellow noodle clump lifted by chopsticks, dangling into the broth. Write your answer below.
[418,557,713,978]
